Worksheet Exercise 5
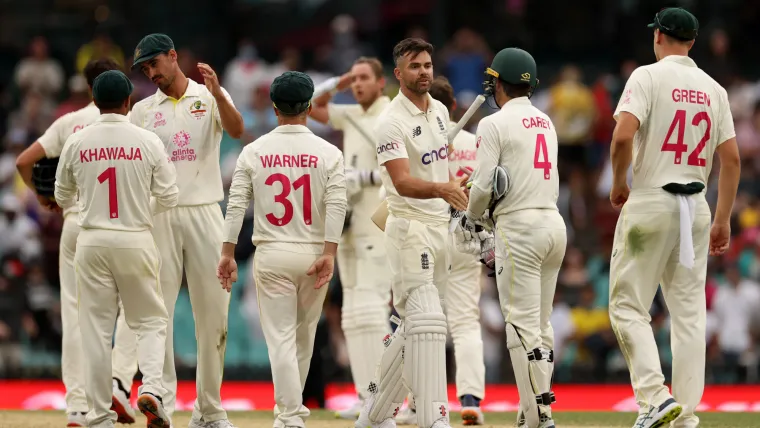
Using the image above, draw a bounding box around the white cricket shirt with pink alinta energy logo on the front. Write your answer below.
[129,79,232,206]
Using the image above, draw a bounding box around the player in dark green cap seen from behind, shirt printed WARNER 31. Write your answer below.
[217,71,347,428]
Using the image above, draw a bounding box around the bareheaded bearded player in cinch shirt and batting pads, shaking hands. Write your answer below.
[355,39,467,428]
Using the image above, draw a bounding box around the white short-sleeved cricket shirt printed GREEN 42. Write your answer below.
[614,55,736,189]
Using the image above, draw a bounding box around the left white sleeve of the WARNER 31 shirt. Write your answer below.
[224,146,254,244]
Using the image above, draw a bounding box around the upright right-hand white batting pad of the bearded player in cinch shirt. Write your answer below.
[404,284,449,428]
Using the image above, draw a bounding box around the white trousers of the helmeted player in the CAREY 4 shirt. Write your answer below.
[495,210,567,351]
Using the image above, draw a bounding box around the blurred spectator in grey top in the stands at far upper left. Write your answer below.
[14,36,64,103]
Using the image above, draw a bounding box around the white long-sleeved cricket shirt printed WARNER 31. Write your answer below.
[224,125,346,254]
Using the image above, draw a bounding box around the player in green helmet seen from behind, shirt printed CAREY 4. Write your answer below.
[465,48,567,428]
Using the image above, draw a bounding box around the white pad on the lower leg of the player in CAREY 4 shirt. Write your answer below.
[507,323,539,428]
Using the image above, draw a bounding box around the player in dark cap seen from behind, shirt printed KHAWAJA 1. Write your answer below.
[55,70,179,428]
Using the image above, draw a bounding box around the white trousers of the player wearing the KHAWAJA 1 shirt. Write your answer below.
[75,230,168,426]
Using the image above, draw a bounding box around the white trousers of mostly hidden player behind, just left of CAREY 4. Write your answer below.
[443,235,486,400]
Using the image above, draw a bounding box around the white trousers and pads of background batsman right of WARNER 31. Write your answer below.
[338,229,391,399]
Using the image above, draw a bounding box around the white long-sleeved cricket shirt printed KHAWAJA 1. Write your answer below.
[55,114,179,247]
